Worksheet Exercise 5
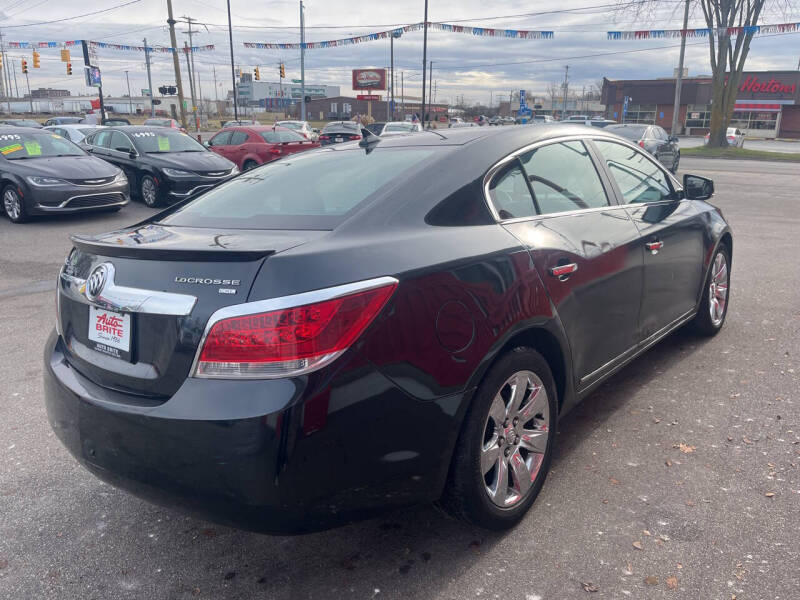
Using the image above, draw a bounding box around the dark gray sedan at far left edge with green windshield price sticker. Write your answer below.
[0,127,130,223]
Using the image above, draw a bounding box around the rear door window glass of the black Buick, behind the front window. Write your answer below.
[521,142,608,215]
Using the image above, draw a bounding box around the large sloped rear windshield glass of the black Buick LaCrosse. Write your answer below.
[161,148,434,229]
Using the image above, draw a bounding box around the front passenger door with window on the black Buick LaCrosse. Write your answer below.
[593,140,706,339]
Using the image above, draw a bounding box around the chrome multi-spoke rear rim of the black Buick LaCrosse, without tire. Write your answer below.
[481,371,550,508]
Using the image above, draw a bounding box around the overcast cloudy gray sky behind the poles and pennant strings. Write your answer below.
[0,0,800,103]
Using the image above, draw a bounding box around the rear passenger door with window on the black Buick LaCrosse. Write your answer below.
[490,140,642,387]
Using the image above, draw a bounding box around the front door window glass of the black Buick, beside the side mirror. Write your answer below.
[594,140,675,204]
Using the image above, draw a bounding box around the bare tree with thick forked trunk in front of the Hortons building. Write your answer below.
[621,0,793,148]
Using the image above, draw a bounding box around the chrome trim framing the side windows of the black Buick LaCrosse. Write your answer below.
[483,132,683,225]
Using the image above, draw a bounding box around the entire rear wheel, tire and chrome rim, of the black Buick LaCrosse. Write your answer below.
[442,348,558,531]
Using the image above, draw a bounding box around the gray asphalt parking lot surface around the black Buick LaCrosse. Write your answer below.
[0,159,800,600]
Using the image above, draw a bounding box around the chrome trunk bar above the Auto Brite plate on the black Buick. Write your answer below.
[58,263,197,317]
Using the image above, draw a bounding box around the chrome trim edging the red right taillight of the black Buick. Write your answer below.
[189,276,399,379]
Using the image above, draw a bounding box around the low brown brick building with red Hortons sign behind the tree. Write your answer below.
[602,71,800,139]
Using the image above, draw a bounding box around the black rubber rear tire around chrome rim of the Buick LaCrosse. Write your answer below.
[441,348,558,531]
